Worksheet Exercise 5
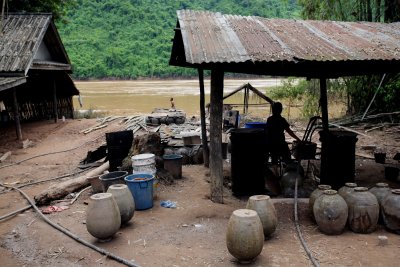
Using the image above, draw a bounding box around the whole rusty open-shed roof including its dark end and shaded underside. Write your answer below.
[170,10,400,78]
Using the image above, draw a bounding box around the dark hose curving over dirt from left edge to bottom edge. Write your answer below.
[0,184,139,267]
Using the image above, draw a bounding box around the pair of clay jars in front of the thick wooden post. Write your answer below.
[226,195,278,263]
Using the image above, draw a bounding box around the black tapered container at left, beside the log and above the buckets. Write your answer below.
[106,131,133,171]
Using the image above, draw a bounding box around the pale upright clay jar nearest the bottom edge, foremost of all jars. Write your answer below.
[226,209,264,262]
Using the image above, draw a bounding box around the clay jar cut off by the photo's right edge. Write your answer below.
[382,189,400,234]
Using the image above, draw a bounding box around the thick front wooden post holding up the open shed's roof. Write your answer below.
[210,70,224,203]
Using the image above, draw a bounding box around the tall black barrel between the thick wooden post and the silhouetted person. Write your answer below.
[230,128,266,196]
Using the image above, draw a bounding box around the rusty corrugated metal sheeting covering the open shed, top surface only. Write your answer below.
[177,10,400,64]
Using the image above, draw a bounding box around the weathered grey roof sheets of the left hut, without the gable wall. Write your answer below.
[0,14,70,75]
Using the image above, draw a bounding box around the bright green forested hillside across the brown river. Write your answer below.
[57,0,299,79]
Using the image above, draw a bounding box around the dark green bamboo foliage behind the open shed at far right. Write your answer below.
[298,0,400,114]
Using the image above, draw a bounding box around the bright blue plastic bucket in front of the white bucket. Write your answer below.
[125,173,154,210]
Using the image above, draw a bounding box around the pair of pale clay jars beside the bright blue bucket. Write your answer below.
[86,184,135,241]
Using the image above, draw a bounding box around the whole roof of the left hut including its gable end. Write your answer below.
[0,13,72,77]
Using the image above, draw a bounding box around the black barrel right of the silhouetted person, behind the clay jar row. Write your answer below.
[319,129,358,190]
